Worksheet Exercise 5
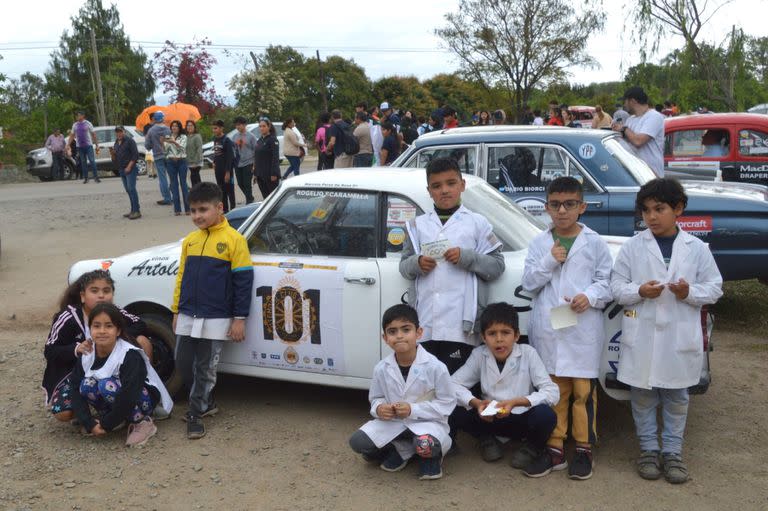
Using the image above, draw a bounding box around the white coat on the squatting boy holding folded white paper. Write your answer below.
[452,344,560,414]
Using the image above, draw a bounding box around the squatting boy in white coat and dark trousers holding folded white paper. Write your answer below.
[451,303,559,477]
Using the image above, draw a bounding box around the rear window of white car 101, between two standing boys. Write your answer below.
[461,182,546,252]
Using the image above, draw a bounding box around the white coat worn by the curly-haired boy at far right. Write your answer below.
[611,229,723,389]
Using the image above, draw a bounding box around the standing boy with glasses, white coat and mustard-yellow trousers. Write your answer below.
[512,177,612,480]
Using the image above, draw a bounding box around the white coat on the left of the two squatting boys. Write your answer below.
[360,346,456,459]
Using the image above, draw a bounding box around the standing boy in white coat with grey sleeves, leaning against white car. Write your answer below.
[400,158,504,374]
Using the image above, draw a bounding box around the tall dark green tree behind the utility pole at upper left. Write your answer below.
[45,0,155,124]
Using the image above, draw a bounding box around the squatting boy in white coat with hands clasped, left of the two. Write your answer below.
[349,304,456,479]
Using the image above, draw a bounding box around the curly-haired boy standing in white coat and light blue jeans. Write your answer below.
[611,179,723,484]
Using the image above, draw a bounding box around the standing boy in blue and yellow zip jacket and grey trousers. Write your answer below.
[171,182,253,438]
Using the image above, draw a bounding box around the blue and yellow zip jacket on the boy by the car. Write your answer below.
[171,218,253,318]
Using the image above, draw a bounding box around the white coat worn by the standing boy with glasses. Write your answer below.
[522,224,613,378]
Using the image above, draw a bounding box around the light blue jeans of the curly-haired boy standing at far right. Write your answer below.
[630,387,688,454]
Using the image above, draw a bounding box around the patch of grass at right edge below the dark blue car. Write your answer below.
[712,279,768,338]
